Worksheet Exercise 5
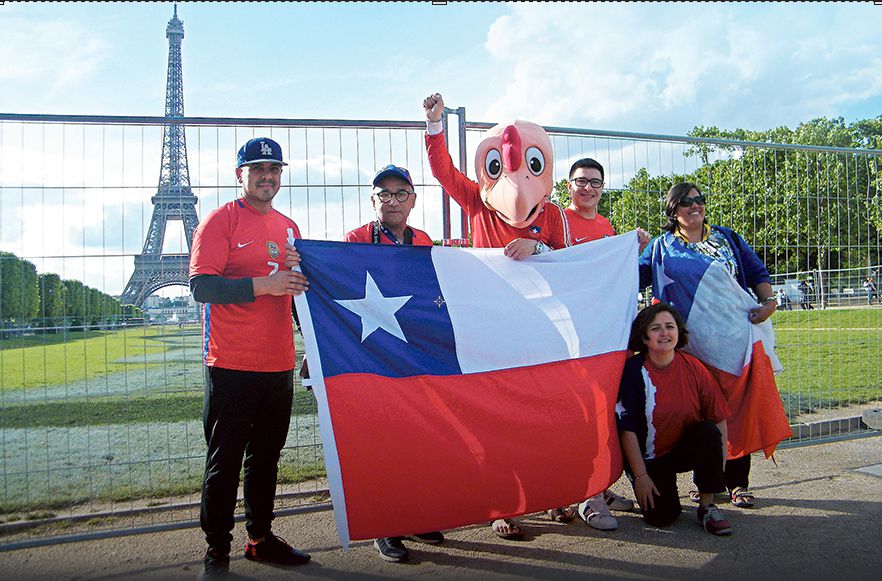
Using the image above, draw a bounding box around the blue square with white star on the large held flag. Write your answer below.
[297,240,461,377]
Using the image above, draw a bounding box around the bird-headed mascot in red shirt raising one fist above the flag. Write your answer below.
[424,95,571,252]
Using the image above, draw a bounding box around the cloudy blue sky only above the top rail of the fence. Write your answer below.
[0,2,882,134]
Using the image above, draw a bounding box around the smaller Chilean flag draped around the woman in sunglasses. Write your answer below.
[652,244,792,459]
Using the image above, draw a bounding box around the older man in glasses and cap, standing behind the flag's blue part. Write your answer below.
[344,165,444,563]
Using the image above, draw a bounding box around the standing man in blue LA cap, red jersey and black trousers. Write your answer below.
[190,137,310,577]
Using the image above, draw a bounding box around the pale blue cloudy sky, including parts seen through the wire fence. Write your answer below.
[0,2,882,294]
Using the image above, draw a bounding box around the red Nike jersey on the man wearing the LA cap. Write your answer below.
[190,200,300,371]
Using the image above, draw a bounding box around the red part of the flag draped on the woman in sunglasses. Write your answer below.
[707,341,793,459]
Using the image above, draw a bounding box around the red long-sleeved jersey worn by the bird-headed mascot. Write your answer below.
[426,133,572,249]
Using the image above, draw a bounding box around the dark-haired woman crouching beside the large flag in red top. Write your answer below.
[616,303,732,535]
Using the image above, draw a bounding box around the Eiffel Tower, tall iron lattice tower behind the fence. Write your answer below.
[120,4,199,307]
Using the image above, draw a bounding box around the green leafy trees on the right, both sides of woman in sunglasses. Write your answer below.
[552,116,882,273]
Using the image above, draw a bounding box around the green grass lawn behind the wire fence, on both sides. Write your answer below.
[0,308,882,515]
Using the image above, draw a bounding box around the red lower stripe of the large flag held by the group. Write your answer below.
[325,352,625,540]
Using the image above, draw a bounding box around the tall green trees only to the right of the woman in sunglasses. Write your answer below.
[687,116,882,272]
